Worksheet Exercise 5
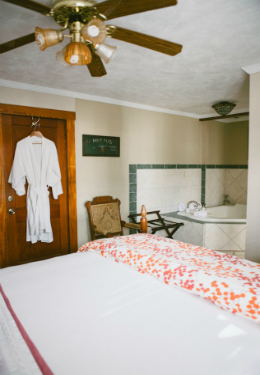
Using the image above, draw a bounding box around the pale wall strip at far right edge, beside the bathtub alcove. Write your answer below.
[246,73,260,262]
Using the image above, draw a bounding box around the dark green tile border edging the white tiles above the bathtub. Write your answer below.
[129,164,248,219]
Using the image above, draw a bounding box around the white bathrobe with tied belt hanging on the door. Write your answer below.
[8,136,63,243]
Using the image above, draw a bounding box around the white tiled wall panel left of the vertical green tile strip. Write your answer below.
[137,168,201,213]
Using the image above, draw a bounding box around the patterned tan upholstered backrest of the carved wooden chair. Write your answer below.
[86,196,123,240]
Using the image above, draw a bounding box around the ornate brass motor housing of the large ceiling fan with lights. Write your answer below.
[50,0,99,27]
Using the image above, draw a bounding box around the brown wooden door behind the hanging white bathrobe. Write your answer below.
[2,115,69,266]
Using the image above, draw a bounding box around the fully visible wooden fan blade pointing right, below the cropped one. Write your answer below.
[108,26,182,56]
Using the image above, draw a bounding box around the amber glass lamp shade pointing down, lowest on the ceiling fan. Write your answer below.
[65,42,92,65]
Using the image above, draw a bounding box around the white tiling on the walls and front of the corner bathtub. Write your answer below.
[137,168,247,254]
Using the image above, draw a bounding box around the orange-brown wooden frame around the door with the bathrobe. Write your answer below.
[0,103,78,267]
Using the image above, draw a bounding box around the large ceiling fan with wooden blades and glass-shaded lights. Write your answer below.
[0,0,182,77]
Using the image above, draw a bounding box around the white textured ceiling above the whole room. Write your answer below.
[0,0,260,117]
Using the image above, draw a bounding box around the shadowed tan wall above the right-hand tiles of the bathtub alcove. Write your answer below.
[224,120,249,165]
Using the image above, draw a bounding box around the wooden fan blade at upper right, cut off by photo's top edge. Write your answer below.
[95,0,177,20]
